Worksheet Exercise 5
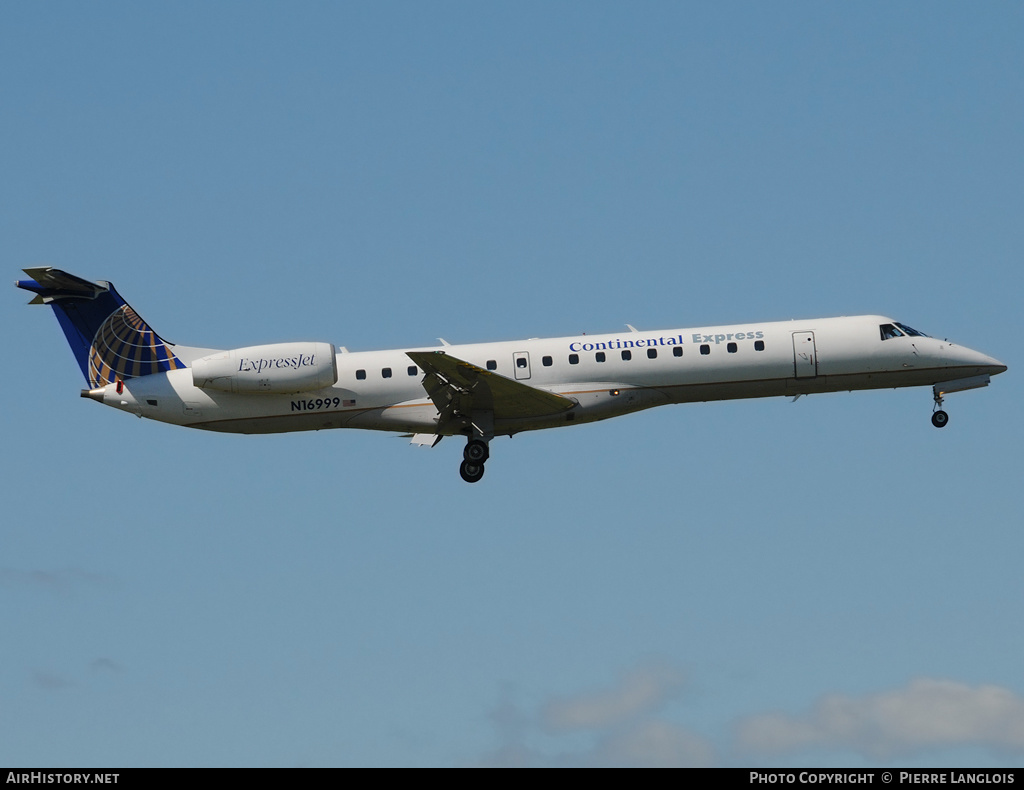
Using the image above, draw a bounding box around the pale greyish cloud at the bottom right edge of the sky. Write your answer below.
[736,678,1024,759]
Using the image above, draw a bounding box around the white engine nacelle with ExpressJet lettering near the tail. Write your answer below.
[191,343,338,394]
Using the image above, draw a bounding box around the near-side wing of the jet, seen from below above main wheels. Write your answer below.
[407,351,577,424]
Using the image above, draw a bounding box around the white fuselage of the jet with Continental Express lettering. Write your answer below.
[95,316,1006,434]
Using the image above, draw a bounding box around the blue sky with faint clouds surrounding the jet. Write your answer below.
[0,2,1024,766]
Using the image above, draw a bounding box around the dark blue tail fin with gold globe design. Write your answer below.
[16,266,185,387]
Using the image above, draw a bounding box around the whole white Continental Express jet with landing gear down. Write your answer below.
[15,266,1007,483]
